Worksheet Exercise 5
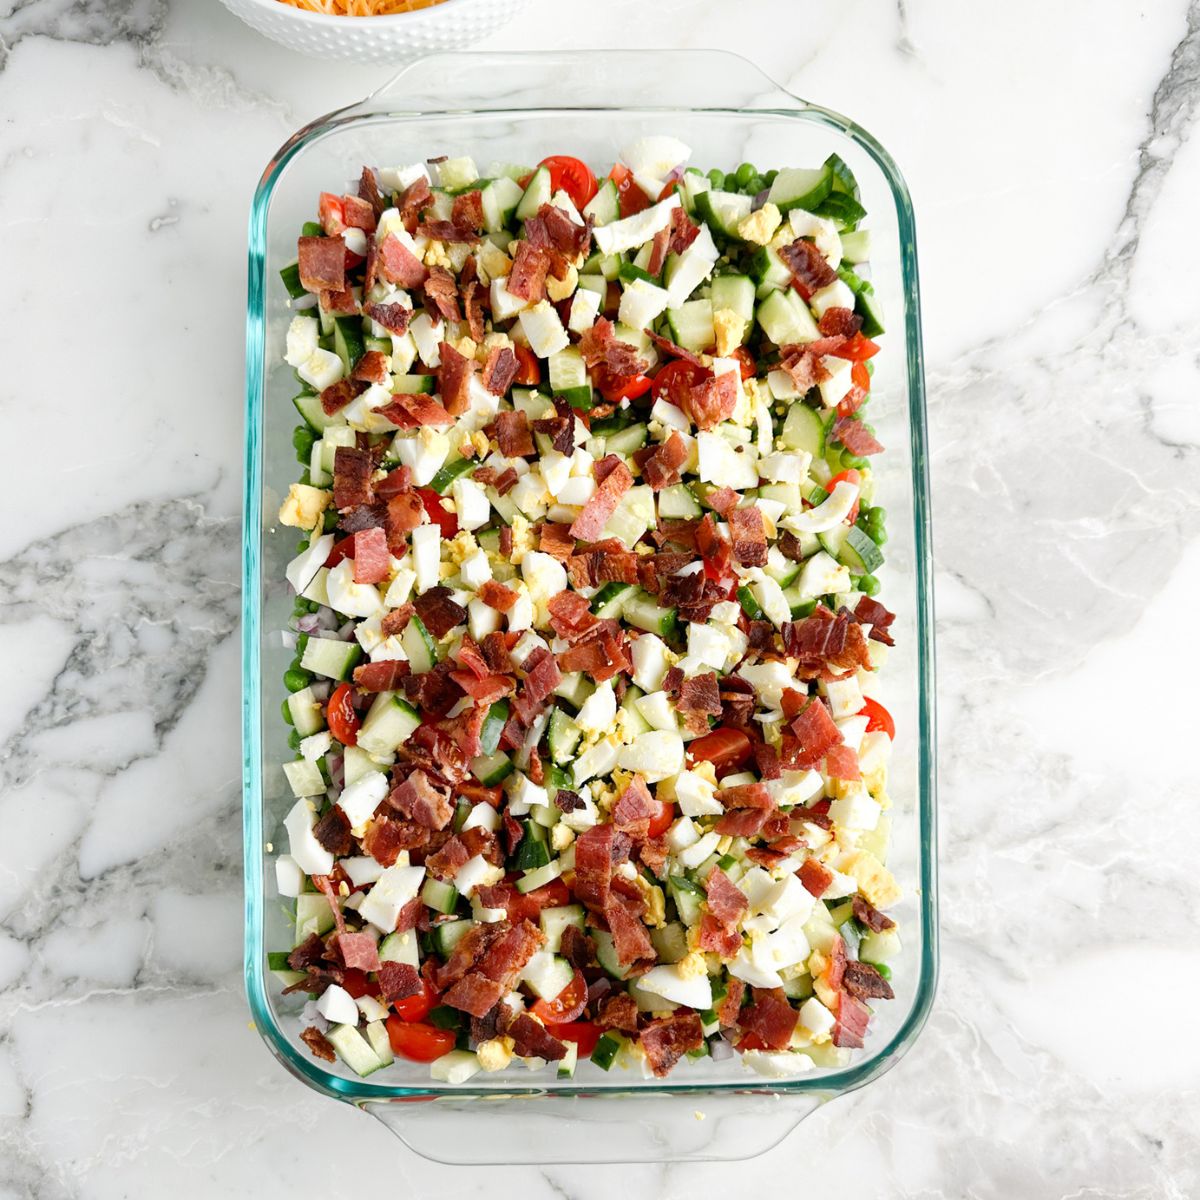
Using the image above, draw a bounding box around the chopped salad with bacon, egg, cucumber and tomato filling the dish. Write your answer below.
[270,137,900,1082]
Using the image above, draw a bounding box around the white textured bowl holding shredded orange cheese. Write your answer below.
[222,0,528,62]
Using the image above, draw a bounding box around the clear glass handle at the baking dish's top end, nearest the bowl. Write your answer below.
[340,50,825,124]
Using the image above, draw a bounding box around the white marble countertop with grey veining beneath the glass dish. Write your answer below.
[0,0,1200,1200]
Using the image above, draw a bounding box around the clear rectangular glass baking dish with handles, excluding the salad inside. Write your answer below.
[242,50,937,1163]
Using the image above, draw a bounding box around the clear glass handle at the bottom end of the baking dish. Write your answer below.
[361,1092,829,1166]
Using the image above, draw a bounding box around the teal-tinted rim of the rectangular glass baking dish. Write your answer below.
[242,49,938,1104]
